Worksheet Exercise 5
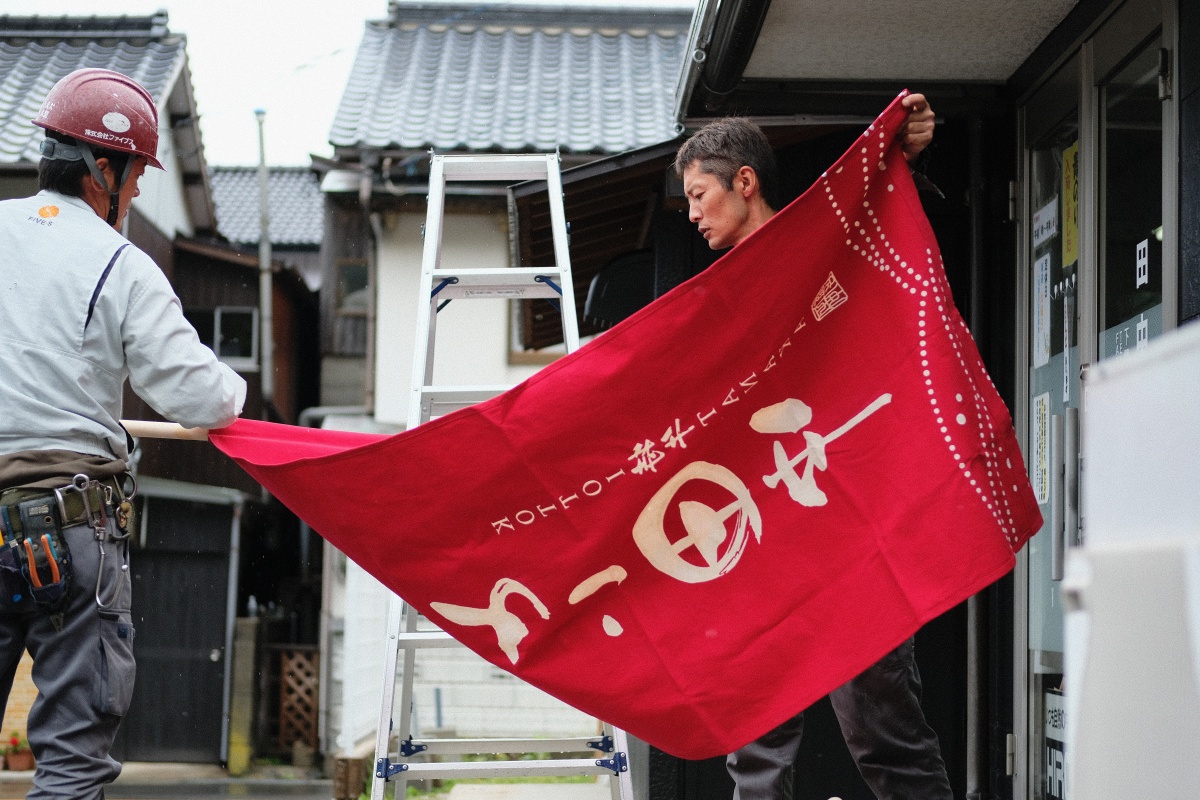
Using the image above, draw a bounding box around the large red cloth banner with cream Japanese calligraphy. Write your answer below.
[211,92,1040,758]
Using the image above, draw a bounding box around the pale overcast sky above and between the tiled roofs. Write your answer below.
[7,0,695,166]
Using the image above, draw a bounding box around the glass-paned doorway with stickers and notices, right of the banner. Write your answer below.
[1014,0,1177,800]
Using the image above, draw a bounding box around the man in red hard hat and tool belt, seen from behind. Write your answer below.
[0,70,246,800]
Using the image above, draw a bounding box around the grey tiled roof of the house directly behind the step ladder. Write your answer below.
[330,4,690,152]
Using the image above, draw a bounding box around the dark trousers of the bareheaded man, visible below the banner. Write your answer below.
[726,638,953,800]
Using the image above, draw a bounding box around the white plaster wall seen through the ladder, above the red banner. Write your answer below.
[376,213,538,425]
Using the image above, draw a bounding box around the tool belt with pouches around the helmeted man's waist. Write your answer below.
[0,475,132,609]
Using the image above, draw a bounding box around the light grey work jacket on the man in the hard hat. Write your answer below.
[0,191,246,458]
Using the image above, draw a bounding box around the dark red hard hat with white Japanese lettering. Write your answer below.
[34,68,162,169]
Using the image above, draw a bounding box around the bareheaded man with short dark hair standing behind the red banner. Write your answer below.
[676,95,953,800]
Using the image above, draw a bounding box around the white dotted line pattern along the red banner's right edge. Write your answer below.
[821,125,1020,551]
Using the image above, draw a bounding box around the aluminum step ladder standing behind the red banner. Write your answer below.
[371,154,634,800]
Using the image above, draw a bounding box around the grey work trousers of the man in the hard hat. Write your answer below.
[0,513,134,800]
